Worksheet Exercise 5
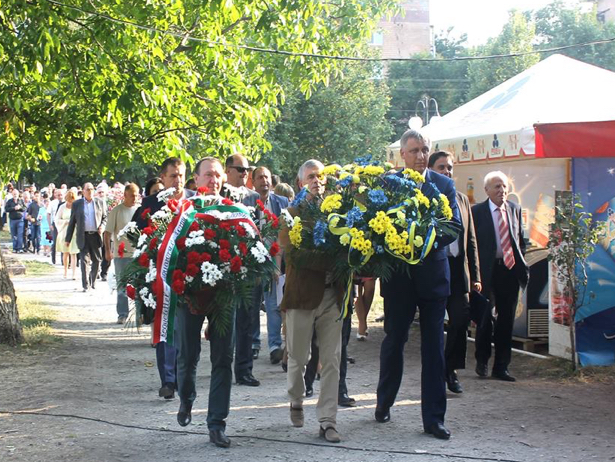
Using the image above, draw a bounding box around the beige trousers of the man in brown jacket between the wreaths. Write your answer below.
[286,289,342,428]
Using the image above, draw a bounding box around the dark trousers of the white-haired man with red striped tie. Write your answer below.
[476,260,519,372]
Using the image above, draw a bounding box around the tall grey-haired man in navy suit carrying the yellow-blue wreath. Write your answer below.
[375,130,460,439]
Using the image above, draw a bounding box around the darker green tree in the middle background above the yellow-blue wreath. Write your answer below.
[260,63,391,184]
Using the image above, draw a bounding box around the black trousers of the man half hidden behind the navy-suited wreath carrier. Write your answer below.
[444,257,470,371]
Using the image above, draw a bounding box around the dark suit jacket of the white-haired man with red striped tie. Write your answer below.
[472,199,530,293]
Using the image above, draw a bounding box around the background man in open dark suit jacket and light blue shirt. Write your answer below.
[65,183,107,292]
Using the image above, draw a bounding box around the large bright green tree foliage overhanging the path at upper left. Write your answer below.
[0,0,396,184]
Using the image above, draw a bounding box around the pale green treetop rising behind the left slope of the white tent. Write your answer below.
[467,10,540,99]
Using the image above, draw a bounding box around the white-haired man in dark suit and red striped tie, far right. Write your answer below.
[472,171,529,382]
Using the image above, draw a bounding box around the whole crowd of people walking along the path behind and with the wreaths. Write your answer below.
[3,126,529,447]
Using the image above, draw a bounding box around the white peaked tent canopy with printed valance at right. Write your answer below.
[390,55,615,162]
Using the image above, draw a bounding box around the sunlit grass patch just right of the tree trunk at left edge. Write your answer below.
[17,296,60,346]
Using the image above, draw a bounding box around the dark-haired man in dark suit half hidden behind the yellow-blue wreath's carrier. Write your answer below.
[428,151,482,393]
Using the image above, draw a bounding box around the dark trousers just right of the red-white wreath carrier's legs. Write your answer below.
[234,284,262,379]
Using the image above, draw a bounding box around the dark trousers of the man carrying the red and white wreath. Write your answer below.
[175,306,234,430]
